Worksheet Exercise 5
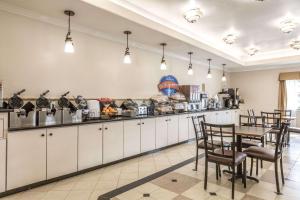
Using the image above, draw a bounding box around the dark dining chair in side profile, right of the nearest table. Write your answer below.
[243,123,289,194]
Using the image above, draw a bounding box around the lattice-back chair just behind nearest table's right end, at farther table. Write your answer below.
[261,112,282,143]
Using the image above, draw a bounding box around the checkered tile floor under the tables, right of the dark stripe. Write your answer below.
[113,135,300,200]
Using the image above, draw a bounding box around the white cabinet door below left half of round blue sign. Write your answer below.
[155,117,168,148]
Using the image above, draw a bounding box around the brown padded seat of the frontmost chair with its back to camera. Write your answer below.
[207,149,247,166]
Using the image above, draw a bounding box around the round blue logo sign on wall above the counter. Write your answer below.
[158,75,178,96]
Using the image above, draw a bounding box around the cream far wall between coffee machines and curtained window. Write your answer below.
[229,66,300,112]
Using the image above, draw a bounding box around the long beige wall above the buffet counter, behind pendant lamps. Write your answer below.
[0,12,225,98]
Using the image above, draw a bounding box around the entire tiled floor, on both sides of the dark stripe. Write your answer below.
[1,135,300,200]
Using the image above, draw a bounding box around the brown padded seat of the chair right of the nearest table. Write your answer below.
[243,146,275,162]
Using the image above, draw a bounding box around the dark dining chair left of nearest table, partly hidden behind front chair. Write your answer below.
[192,115,230,172]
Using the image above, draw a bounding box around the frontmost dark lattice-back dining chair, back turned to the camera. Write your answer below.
[201,121,247,199]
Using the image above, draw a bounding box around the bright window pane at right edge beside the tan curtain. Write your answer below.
[286,80,300,110]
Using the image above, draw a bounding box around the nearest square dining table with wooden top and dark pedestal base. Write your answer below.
[212,126,272,182]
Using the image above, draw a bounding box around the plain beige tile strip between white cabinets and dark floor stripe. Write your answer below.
[0,142,195,200]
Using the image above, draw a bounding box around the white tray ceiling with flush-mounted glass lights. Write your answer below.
[0,0,300,71]
